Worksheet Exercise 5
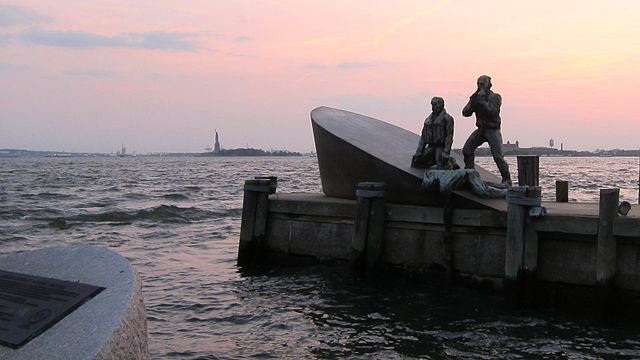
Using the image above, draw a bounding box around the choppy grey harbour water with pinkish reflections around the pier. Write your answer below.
[0,157,640,359]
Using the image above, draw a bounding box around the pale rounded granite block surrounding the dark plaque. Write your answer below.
[0,245,149,360]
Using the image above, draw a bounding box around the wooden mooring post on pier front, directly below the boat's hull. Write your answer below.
[351,182,385,273]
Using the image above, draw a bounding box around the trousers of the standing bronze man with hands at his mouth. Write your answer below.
[462,128,511,182]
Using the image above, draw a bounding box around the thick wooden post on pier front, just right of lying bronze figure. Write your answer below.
[504,186,544,307]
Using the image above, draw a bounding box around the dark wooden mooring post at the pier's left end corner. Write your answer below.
[238,178,275,265]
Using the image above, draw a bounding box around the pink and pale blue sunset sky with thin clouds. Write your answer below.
[0,0,640,153]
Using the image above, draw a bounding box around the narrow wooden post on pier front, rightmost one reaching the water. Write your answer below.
[596,189,620,310]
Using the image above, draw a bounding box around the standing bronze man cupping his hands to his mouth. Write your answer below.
[462,75,511,185]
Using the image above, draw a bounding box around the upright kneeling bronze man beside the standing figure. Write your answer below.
[411,96,460,170]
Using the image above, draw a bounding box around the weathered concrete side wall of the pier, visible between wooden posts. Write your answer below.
[263,194,640,291]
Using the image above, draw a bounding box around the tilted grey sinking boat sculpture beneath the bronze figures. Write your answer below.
[311,107,505,208]
